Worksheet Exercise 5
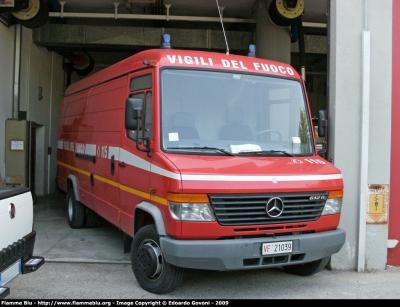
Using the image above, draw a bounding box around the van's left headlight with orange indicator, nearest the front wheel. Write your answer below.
[168,193,215,222]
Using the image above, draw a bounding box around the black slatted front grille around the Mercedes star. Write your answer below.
[209,192,328,226]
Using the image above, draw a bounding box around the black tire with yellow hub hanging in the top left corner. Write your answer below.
[12,0,49,29]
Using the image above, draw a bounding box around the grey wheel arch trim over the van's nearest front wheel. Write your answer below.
[133,202,167,236]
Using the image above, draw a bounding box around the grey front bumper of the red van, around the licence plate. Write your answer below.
[160,228,346,271]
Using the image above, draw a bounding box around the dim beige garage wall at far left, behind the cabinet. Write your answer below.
[0,24,64,196]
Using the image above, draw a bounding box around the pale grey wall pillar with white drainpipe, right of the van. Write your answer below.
[329,0,396,271]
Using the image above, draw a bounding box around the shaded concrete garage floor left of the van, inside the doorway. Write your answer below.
[33,194,130,263]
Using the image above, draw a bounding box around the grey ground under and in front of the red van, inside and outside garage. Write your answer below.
[0,194,400,305]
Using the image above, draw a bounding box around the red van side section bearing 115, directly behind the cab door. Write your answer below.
[87,76,128,226]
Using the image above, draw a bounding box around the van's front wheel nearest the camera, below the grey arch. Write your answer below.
[131,225,184,294]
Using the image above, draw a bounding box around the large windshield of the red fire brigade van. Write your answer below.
[161,69,314,156]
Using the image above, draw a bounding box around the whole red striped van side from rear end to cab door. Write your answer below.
[58,76,128,226]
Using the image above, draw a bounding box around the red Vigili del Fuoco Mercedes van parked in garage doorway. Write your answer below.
[58,35,345,294]
